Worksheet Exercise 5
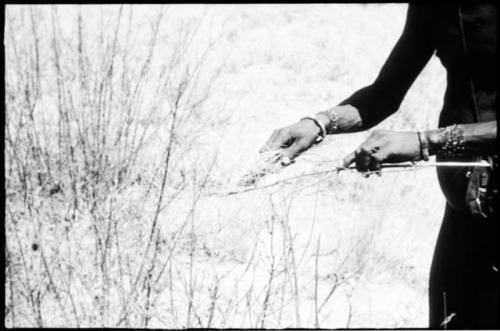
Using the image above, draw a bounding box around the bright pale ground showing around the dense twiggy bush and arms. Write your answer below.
[4,4,446,328]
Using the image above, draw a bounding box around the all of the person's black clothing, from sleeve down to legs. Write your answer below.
[341,4,500,328]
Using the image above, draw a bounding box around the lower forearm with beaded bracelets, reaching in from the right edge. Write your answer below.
[424,121,497,155]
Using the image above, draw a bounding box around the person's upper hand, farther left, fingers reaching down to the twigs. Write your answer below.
[259,119,321,166]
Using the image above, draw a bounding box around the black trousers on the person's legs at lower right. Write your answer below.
[429,205,500,329]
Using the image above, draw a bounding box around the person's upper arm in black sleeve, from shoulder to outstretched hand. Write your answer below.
[260,6,434,160]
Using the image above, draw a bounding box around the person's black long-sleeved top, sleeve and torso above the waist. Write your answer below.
[341,4,497,210]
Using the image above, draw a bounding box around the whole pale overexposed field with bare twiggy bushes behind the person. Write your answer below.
[4,4,446,328]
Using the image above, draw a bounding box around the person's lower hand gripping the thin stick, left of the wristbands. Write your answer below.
[344,130,420,172]
